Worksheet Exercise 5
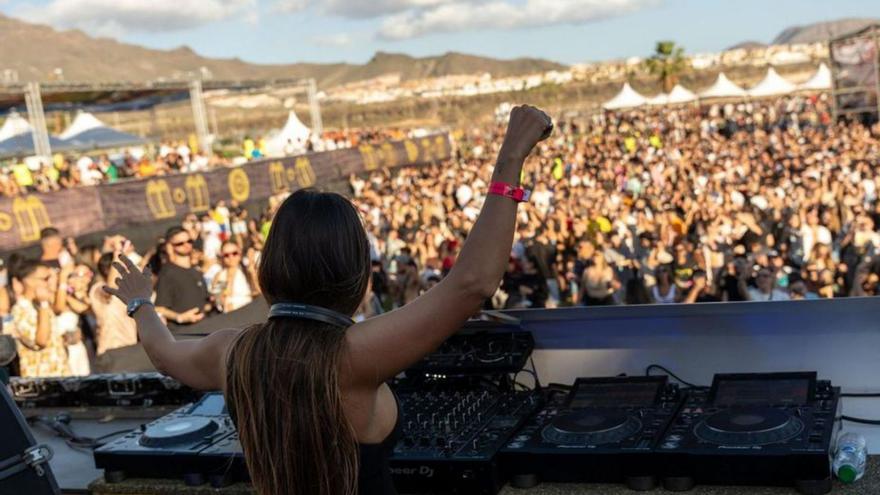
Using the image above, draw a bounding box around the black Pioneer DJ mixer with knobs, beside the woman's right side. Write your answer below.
[391,382,541,495]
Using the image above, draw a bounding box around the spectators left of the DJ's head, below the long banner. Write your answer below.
[0,196,283,376]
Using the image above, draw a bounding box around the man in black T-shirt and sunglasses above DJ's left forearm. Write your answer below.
[156,227,211,331]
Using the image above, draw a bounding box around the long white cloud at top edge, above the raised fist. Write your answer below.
[378,0,656,40]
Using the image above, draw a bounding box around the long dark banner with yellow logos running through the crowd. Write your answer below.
[0,134,452,250]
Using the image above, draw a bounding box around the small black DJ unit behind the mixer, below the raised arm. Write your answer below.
[407,322,535,376]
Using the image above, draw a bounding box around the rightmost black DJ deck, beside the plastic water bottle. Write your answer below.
[657,373,840,494]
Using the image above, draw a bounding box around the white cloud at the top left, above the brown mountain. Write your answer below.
[15,0,257,37]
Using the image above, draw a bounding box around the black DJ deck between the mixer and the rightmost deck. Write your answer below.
[502,376,682,490]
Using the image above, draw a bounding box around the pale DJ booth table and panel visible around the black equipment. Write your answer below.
[25,298,880,495]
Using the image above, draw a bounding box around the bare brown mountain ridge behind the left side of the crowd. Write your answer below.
[0,14,564,87]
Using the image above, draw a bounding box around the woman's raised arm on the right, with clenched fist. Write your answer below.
[346,106,552,386]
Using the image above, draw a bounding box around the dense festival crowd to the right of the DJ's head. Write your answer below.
[351,95,880,316]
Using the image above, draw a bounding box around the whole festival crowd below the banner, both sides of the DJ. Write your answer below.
[0,95,880,376]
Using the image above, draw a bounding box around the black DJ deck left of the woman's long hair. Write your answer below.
[95,393,247,486]
